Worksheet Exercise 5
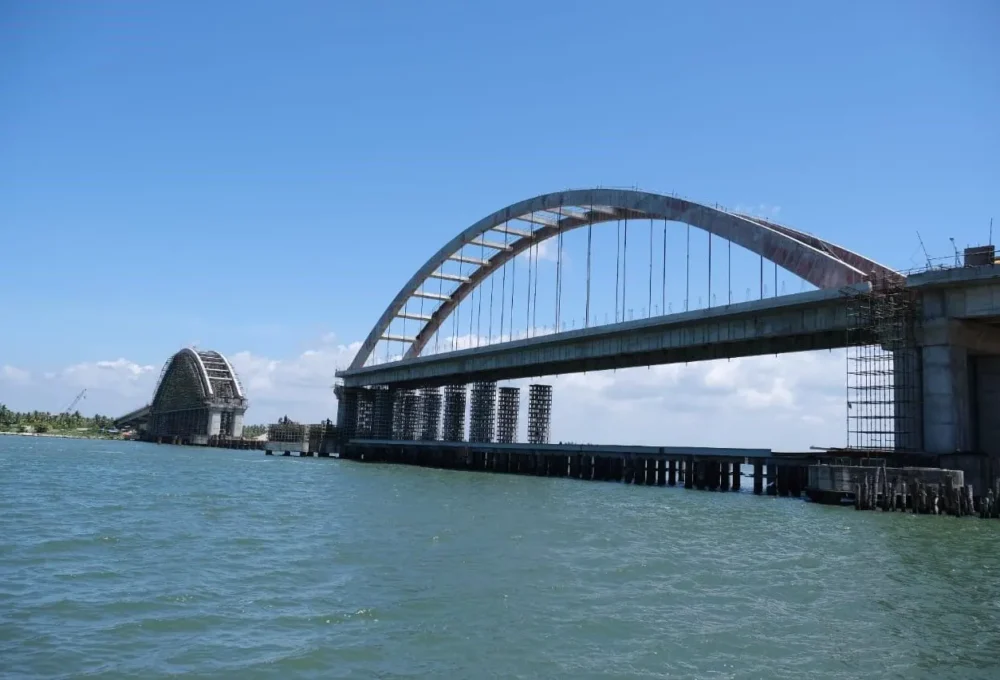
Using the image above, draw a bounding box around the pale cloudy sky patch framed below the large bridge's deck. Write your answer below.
[536,352,845,450]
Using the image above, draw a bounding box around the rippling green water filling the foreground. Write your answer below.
[0,437,1000,679]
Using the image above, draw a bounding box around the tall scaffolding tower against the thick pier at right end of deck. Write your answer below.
[847,276,922,451]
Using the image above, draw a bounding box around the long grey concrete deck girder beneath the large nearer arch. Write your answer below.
[337,284,870,387]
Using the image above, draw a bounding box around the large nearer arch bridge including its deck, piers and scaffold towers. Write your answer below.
[337,189,1000,488]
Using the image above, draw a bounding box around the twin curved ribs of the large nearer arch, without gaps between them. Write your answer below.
[349,189,897,370]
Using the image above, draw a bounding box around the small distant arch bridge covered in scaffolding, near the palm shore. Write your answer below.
[146,348,247,444]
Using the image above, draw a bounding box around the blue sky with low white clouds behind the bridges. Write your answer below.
[0,0,1000,448]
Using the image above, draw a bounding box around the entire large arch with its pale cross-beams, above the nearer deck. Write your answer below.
[348,188,900,371]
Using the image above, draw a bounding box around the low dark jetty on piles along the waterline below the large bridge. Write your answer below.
[330,439,1000,517]
